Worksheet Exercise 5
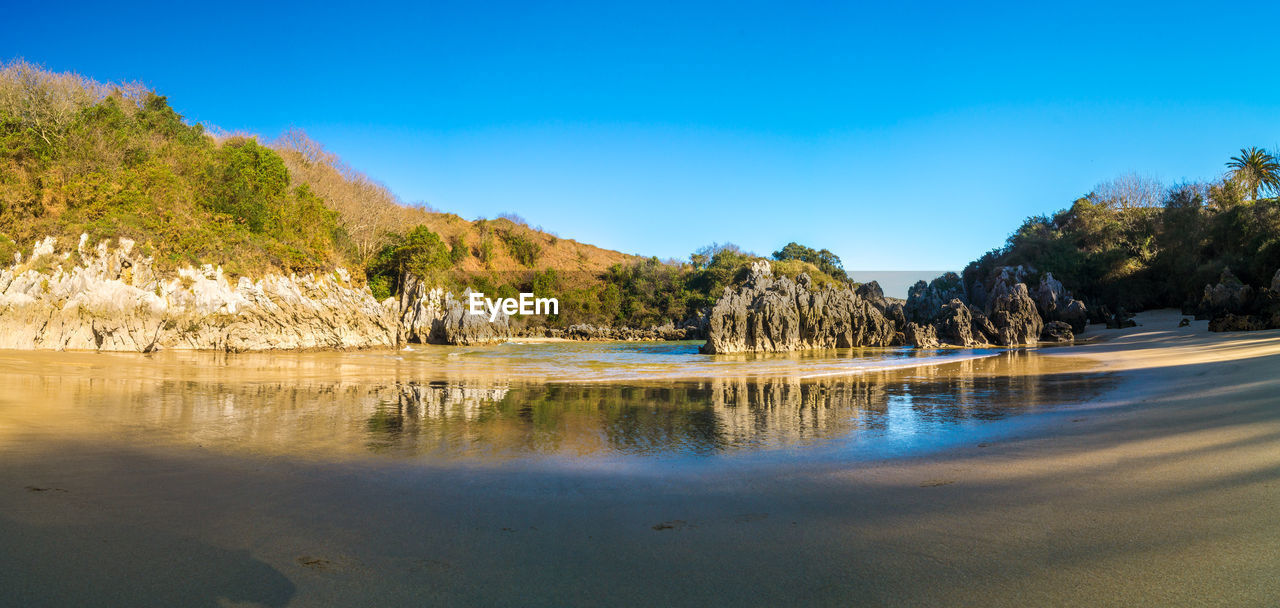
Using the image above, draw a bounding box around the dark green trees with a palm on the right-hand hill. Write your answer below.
[964,154,1280,310]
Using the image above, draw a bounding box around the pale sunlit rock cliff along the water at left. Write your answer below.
[0,237,507,352]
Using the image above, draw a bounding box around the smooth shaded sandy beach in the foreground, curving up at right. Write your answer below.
[0,312,1280,605]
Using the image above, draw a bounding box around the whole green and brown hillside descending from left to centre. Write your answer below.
[0,60,870,328]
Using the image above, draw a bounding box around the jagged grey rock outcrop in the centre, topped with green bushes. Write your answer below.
[701,261,895,353]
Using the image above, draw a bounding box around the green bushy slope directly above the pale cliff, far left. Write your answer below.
[0,61,349,273]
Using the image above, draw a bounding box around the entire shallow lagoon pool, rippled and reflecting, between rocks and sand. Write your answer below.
[0,343,1110,463]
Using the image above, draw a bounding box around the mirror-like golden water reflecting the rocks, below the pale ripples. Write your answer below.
[0,353,1110,460]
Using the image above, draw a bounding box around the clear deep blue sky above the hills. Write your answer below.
[0,1,1280,270]
